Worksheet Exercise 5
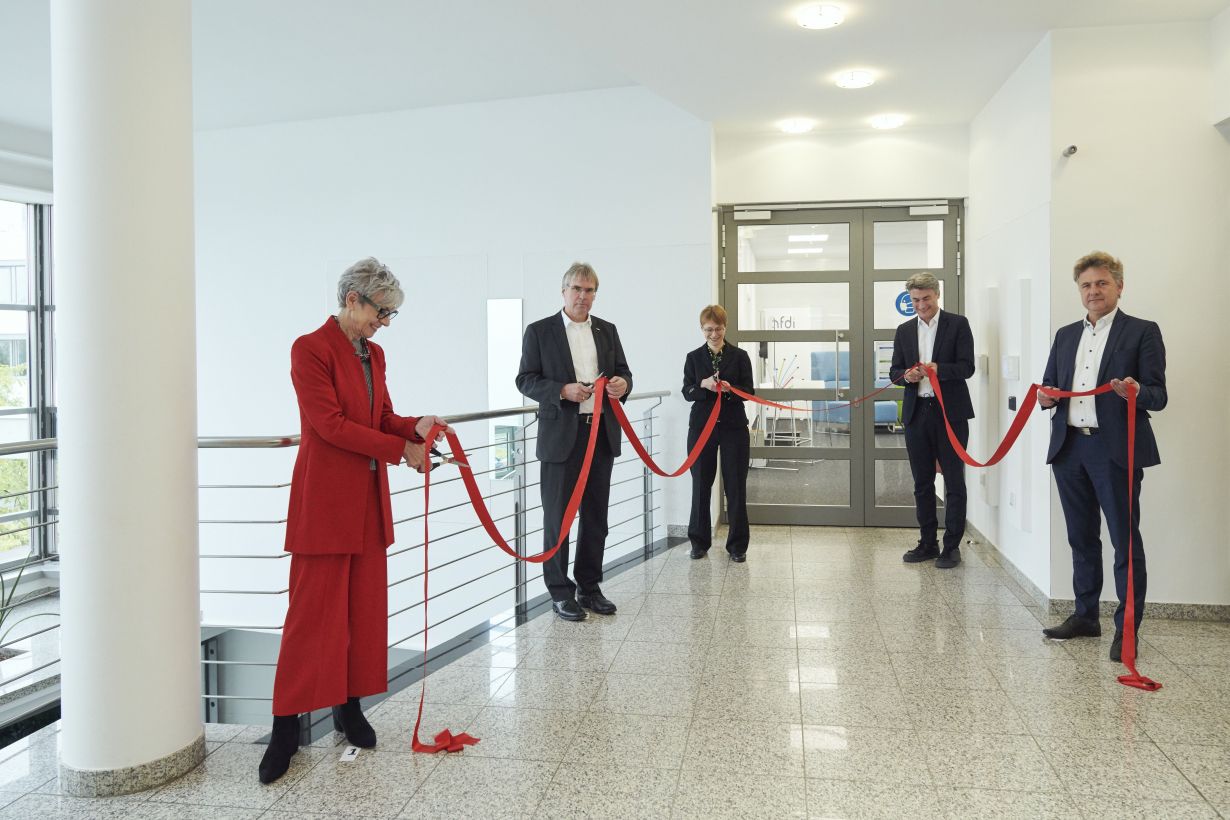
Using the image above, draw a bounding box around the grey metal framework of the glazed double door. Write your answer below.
[715,199,963,526]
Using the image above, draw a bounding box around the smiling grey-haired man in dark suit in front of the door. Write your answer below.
[889,273,974,569]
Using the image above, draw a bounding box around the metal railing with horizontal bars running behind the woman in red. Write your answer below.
[0,391,670,720]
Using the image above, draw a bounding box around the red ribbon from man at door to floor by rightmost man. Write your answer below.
[915,364,1161,692]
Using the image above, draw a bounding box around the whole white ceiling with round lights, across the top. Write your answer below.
[0,0,1230,137]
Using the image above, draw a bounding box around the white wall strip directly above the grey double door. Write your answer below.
[715,127,969,203]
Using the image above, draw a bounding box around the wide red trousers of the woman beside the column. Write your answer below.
[273,472,389,714]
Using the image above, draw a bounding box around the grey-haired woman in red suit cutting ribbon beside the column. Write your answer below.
[260,257,452,783]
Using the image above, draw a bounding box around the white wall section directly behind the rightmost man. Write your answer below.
[1050,22,1230,604]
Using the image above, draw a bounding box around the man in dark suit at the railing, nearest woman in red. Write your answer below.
[517,262,632,621]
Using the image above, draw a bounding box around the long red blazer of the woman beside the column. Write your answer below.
[285,316,422,554]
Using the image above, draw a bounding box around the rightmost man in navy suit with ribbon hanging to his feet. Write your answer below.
[1038,251,1166,660]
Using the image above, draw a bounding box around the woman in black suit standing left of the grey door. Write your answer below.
[684,305,755,563]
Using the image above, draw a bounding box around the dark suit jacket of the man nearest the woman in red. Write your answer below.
[517,311,632,462]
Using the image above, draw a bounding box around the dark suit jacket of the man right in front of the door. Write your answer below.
[888,310,974,424]
